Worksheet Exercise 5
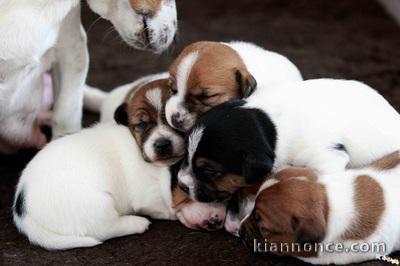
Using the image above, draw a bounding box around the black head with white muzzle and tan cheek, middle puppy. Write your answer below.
[178,100,276,202]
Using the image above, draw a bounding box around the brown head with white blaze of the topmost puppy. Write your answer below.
[166,42,257,132]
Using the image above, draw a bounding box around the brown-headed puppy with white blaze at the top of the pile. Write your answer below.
[165,42,302,132]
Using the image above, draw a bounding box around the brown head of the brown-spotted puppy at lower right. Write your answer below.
[239,168,329,257]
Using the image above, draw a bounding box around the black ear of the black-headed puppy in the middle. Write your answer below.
[243,153,274,184]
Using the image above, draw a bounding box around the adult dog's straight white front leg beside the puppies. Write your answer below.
[52,5,89,138]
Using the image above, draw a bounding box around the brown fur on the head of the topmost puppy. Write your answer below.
[169,41,251,114]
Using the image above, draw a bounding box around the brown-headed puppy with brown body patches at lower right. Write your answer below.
[240,152,400,264]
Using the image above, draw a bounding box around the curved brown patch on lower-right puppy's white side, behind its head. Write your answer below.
[342,175,385,240]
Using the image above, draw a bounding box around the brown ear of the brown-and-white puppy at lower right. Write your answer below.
[292,214,326,244]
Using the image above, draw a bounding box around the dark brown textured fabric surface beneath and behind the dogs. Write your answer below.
[0,0,400,265]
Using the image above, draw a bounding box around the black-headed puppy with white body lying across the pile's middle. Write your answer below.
[178,79,400,202]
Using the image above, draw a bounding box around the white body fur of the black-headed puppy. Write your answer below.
[244,79,400,173]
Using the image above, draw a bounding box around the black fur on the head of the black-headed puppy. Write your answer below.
[186,100,277,200]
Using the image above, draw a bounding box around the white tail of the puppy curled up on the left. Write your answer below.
[14,214,102,250]
